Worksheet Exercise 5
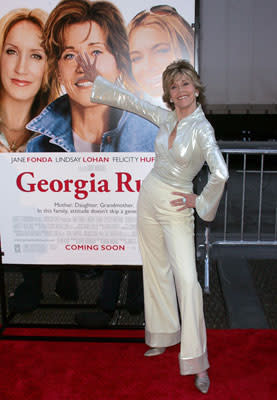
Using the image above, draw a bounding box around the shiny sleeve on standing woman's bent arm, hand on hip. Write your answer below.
[193,125,229,221]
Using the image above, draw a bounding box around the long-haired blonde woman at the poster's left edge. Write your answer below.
[0,8,55,152]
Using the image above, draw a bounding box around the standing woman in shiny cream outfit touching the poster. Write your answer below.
[78,55,228,393]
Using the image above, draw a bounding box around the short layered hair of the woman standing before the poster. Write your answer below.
[163,60,205,110]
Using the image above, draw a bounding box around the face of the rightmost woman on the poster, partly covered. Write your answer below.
[129,24,178,97]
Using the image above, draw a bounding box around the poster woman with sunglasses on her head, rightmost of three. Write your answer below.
[128,5,194,107]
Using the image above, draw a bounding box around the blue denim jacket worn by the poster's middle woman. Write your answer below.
[27,94,158,152]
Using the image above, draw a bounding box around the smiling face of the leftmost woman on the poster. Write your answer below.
[0,21,46,101]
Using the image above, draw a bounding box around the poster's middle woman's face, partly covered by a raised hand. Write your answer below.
[58,21,119,107]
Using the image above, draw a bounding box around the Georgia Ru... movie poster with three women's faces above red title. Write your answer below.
[0,0,195,265]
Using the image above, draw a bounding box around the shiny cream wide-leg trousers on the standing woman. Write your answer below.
[138,172,209,375]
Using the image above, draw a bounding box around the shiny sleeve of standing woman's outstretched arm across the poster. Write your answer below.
[90,76,170,126]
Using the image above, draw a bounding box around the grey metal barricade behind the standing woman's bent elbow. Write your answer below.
[199,143,277,293]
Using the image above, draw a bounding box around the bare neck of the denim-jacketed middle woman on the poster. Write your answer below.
[71,104,117,144]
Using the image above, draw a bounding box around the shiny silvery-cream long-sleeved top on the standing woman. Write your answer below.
[91,76,228,221]
